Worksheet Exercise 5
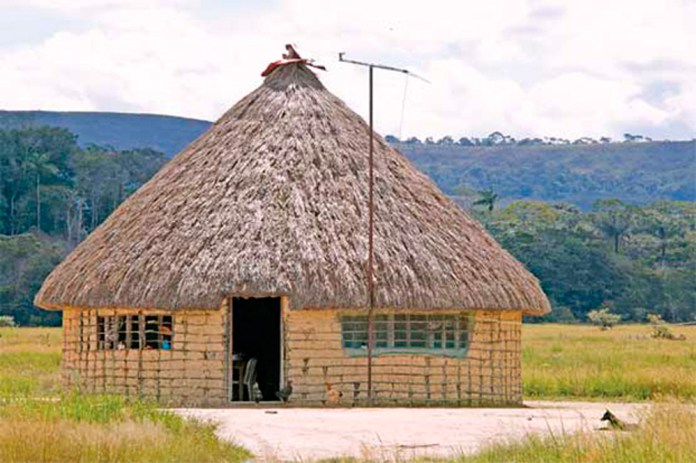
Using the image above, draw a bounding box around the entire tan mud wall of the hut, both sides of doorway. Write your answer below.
[62,298,522,406]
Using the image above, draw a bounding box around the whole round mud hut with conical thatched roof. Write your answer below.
[35,49,549,406]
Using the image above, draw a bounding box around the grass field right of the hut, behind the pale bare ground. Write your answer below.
[522,324,696,401]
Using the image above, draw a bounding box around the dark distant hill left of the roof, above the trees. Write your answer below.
[0,111,211,156]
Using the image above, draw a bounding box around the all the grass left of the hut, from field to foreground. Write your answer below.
[0,328,251,463]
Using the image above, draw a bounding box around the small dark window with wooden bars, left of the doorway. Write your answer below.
[97,315,173,350]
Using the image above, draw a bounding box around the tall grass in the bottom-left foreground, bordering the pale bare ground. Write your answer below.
[0,394,250,463]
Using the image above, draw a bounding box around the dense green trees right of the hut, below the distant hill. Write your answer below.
[473,199,696,322]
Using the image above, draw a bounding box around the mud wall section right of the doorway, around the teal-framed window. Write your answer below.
[284,310,522,406]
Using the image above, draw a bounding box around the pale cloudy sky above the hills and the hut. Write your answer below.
[0,0,696,140]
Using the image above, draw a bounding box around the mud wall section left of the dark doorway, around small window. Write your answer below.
[62,309,227,406]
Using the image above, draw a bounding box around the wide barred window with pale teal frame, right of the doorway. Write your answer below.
[341,314,470,356]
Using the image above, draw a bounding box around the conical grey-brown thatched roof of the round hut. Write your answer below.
[35,55,549,314]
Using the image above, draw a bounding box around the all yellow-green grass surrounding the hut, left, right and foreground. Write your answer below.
[0,325,696,463]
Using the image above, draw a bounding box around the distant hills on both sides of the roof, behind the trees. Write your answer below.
[0,111,696,209]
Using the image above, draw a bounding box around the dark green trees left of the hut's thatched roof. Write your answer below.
[0,127,166,324]
